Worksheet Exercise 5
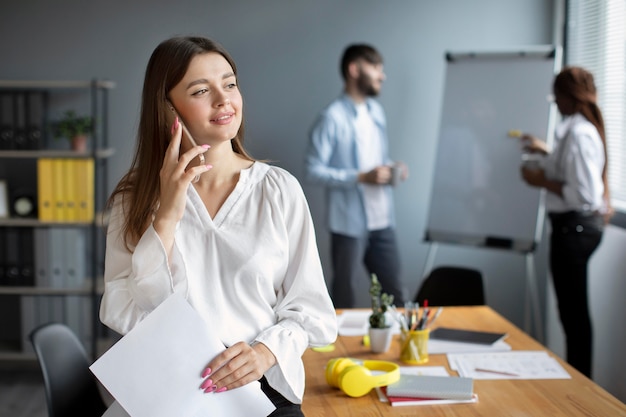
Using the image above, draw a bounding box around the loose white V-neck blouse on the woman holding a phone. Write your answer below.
[100,162,337,403]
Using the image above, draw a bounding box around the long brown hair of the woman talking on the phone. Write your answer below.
[107,36,253,250]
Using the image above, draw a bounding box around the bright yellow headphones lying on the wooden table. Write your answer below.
[326,358,400,397]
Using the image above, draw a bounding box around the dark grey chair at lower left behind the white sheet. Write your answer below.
[30,323,107,417]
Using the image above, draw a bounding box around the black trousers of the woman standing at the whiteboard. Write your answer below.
[549,211,604,378]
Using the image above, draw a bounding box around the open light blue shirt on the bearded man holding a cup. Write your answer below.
[305,94,395,237]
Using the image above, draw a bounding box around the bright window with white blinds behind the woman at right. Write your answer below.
[564,0,626,225]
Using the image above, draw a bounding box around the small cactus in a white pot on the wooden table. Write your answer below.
[369,274,393,353]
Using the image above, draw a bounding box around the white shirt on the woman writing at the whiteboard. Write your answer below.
[543,113,605,212]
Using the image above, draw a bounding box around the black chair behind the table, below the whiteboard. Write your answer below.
[415,266,485,306]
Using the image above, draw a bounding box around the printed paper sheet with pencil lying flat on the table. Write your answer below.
[448,350,571,379]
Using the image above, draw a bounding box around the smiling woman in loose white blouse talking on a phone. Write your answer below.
[100,37,337,416]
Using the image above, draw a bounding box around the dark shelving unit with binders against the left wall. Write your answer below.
[0,80,115,361]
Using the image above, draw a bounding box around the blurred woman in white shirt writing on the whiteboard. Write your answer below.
[522,67,613,377]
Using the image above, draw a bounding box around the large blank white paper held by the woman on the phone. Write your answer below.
[90,294,274,417]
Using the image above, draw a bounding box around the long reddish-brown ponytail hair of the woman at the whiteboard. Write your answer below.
[553,66,609,203]
